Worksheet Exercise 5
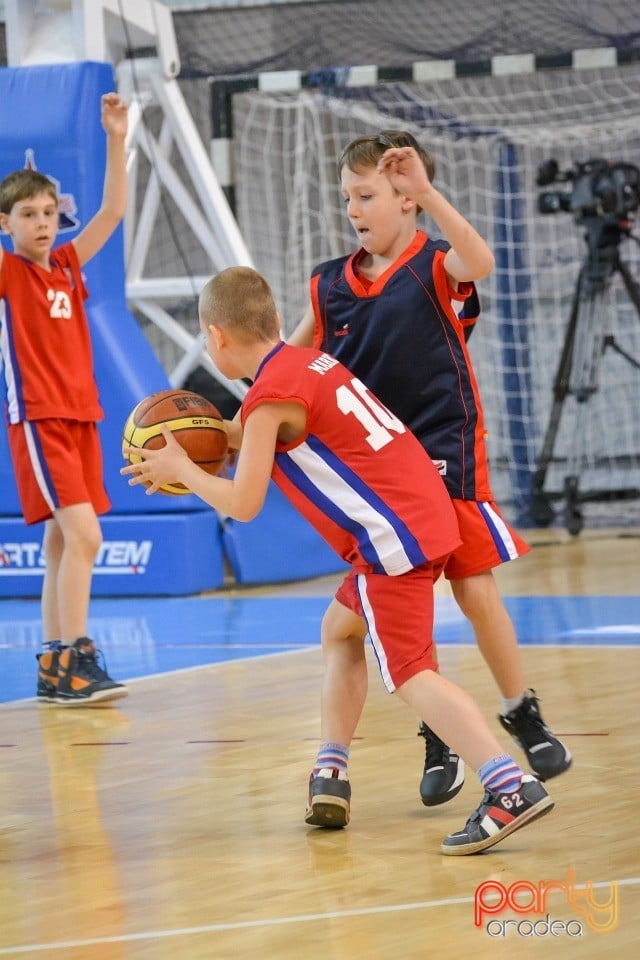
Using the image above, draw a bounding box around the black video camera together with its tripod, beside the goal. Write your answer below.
[531,158,640,534]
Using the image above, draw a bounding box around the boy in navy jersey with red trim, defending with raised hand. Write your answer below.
[289,131,571,806]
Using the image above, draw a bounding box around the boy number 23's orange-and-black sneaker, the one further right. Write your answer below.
[55,637,129,707]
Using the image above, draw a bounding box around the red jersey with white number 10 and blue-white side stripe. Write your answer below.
[242,343,460,576]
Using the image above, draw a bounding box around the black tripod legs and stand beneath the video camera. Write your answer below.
[531,217,640,535]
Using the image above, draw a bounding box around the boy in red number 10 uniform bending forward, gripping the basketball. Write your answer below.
[121,267,553,856]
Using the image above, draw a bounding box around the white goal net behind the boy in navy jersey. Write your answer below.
[233,64,640,523]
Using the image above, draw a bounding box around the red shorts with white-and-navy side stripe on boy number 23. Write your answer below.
[8,420,111,523]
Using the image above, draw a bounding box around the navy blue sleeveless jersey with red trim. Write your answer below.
[311,231,493,500]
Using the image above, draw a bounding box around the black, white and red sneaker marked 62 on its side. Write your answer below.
[440,774,553,857]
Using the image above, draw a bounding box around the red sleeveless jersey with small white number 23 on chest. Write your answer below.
[0,243,103,423]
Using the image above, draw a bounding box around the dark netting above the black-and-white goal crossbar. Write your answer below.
[174,0,640,75]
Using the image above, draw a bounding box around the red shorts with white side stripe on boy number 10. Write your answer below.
[335,563,442,693]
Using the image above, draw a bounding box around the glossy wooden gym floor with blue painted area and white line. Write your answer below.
[0,530,640,960]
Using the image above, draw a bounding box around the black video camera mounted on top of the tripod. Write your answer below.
[536,158,640,223]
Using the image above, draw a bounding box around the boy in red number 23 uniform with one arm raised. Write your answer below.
[0,93,127,706]
